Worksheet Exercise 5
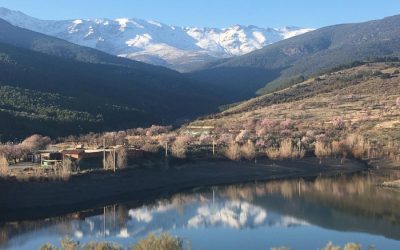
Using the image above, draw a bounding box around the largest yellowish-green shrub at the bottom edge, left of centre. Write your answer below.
[132,233,183,250]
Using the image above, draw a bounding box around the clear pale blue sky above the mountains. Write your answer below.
[0,0,400,28]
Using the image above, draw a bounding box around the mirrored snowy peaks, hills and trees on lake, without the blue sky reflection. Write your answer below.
[0,172,400,248]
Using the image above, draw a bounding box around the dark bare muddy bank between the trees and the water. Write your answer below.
[0,158,367,221]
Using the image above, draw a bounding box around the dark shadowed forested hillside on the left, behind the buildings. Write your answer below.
[0,43,218,140]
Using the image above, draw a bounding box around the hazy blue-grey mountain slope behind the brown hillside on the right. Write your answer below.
[191,15,400,97]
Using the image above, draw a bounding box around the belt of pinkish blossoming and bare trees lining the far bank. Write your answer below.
[57,110,366,164]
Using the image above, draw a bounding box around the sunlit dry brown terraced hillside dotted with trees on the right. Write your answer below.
[190,63,400,163]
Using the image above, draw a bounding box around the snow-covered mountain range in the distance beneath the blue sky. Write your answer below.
[0,8,312,71]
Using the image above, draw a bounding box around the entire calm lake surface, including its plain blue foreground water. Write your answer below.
[0,174,400,249]
